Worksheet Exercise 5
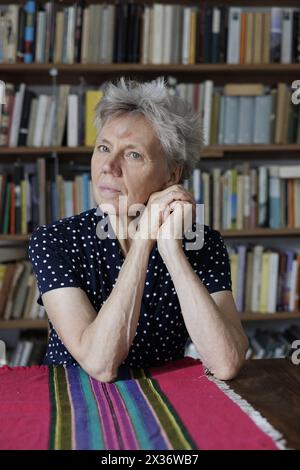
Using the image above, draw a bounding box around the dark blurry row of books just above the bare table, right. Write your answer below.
[246,325,300,359]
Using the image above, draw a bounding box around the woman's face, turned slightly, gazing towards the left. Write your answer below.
[91,114,179,214]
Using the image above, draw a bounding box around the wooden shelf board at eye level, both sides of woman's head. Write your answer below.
[0,144,300,163]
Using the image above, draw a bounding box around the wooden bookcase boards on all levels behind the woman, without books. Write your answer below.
[0,0,300,364]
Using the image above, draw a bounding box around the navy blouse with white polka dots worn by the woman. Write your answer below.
[29,208,231,367]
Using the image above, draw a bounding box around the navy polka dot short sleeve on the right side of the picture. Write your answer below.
[192,226,232,294]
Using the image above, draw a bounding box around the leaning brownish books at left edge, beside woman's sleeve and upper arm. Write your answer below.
[0,260,45,320]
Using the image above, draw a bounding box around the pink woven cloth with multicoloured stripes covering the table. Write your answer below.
[0,358,277,450]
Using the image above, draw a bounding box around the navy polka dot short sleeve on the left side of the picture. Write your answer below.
[28,225,82,305]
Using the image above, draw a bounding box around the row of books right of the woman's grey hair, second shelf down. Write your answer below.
[173,81,300,145]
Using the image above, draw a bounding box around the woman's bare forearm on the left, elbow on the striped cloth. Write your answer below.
[80,240,151,381]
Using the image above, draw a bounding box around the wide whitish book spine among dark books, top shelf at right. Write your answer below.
[227,7,241,64]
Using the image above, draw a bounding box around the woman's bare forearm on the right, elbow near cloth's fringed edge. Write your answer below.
[163,249,245,378]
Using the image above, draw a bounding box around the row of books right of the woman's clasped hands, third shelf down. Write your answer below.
[183,162,300,230]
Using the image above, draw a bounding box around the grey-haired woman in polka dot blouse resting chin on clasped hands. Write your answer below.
[29,78,247,382]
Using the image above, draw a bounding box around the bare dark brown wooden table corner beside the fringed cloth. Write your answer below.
[227,358,300,449]
